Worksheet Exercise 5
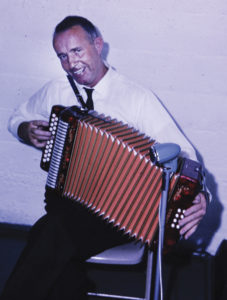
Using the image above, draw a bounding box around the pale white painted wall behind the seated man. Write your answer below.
[0,0,227,254]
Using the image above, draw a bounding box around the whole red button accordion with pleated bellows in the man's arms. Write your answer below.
[41,106,200,251]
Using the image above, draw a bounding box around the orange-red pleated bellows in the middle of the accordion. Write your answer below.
[63,118,178,243]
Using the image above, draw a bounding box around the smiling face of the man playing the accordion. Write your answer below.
[53,26,106,87]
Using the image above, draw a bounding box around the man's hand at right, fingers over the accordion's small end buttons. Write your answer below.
[179,193,207,239]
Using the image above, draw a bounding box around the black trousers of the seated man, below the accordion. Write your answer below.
[0,192,129,300]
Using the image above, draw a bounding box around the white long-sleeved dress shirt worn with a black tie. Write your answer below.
[9,68,196,160]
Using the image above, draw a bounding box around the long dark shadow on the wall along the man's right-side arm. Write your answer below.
[156,95,223,252]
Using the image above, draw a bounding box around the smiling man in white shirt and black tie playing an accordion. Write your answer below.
[2,17,206,300]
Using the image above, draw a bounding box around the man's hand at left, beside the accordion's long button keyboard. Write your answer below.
[18,120,51,148]
